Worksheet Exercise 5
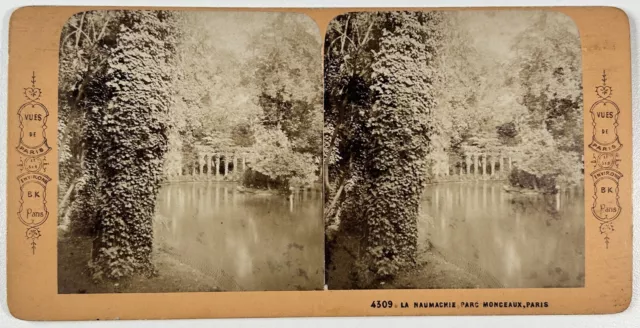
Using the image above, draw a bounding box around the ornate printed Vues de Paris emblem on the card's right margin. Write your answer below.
[589,71,623,249]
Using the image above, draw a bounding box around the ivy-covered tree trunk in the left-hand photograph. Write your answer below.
[91,11,175,279]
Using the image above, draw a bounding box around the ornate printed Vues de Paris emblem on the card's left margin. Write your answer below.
[16,72,51,254]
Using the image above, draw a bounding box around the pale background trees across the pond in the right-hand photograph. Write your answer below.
[430,12,583,188]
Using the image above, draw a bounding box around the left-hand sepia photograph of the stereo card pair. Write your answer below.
[57,10,325,294]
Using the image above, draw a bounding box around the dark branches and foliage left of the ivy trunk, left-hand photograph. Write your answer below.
[58,11,121,234]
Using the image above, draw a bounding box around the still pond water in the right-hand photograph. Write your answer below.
[418,181,585,288]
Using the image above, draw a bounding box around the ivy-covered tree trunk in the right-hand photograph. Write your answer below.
[345,12,440,279]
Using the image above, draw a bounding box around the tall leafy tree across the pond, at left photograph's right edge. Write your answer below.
[249,14,322,189]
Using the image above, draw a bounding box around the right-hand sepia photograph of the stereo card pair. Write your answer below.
[323,10,584,290]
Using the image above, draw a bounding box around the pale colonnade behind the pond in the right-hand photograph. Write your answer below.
[433,154,514,179]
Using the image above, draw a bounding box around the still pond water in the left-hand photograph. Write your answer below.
[154,182,324,291]
